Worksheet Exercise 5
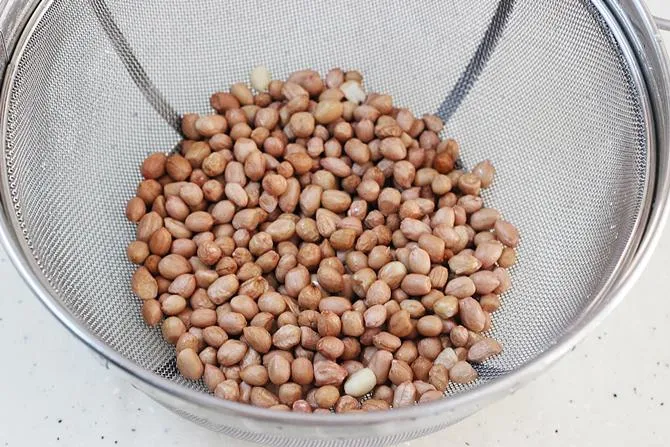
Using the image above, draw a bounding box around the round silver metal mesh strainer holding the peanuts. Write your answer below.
[0,0,670,446]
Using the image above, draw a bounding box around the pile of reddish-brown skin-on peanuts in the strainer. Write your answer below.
[126,67,519,413]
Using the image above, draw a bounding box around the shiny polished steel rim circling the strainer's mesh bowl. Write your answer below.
[0,0,670,427]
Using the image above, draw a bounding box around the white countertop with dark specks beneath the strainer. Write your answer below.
[0,0,670,447]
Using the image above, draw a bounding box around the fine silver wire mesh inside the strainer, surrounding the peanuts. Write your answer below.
[3,0,650,440]
